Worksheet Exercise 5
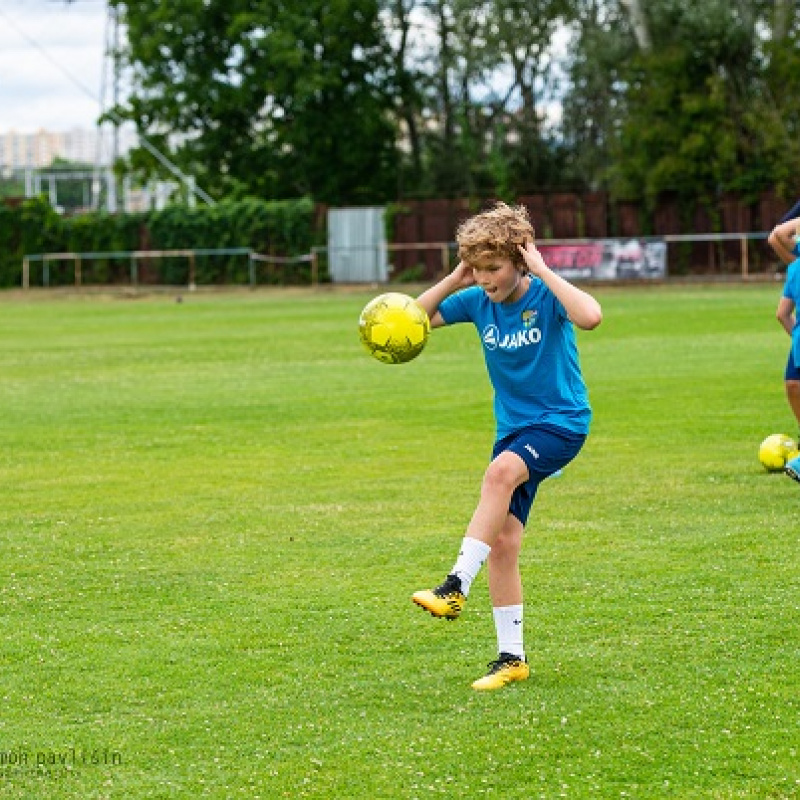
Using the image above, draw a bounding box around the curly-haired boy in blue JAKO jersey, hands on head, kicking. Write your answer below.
[412,203,602,690]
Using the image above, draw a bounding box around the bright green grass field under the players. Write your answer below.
[0,284,800,800]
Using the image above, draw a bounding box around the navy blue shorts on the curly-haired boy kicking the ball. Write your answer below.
[492,425,586,525]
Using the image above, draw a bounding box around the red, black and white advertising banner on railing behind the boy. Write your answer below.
[536,239,667,280]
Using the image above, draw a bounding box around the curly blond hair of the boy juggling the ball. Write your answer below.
[456,202,533,272]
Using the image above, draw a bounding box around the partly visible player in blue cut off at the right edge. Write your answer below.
[768,219,800,481]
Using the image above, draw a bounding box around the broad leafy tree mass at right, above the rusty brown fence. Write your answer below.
[565,0,800,210]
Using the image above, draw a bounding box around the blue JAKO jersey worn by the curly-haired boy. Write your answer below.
[439,276,592,439]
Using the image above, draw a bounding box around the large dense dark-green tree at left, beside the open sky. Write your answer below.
[112,0,396,204]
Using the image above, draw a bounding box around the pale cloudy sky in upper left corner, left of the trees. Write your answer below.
[0,0,111,133]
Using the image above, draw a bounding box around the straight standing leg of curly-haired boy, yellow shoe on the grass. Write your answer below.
[472,514,530,691]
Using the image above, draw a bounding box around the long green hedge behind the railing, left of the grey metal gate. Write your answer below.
[0,197,324,287]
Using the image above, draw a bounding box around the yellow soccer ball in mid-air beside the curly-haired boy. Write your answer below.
[358,292,431,364]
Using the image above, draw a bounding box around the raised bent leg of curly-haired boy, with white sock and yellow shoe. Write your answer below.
[411,452,528,619]
